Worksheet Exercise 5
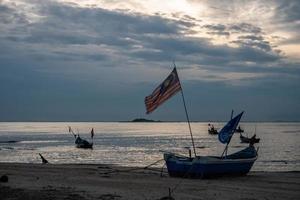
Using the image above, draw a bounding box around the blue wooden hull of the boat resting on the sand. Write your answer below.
[164,147,257,178]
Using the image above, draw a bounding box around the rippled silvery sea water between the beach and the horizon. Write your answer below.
[0,122,300,171]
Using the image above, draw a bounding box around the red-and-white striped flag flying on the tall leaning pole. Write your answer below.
[145,67,181,114]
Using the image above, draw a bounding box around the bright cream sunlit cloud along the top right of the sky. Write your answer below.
[45,0,300,62]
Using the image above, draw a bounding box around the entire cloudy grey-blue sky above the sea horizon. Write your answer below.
[0,0,300,121]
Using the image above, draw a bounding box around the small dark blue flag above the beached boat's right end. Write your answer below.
[219,111,244,144]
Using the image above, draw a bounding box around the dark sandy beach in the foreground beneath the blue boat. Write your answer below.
[0,163,300,200]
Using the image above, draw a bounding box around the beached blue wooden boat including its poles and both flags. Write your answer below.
[145,64,258,178]
